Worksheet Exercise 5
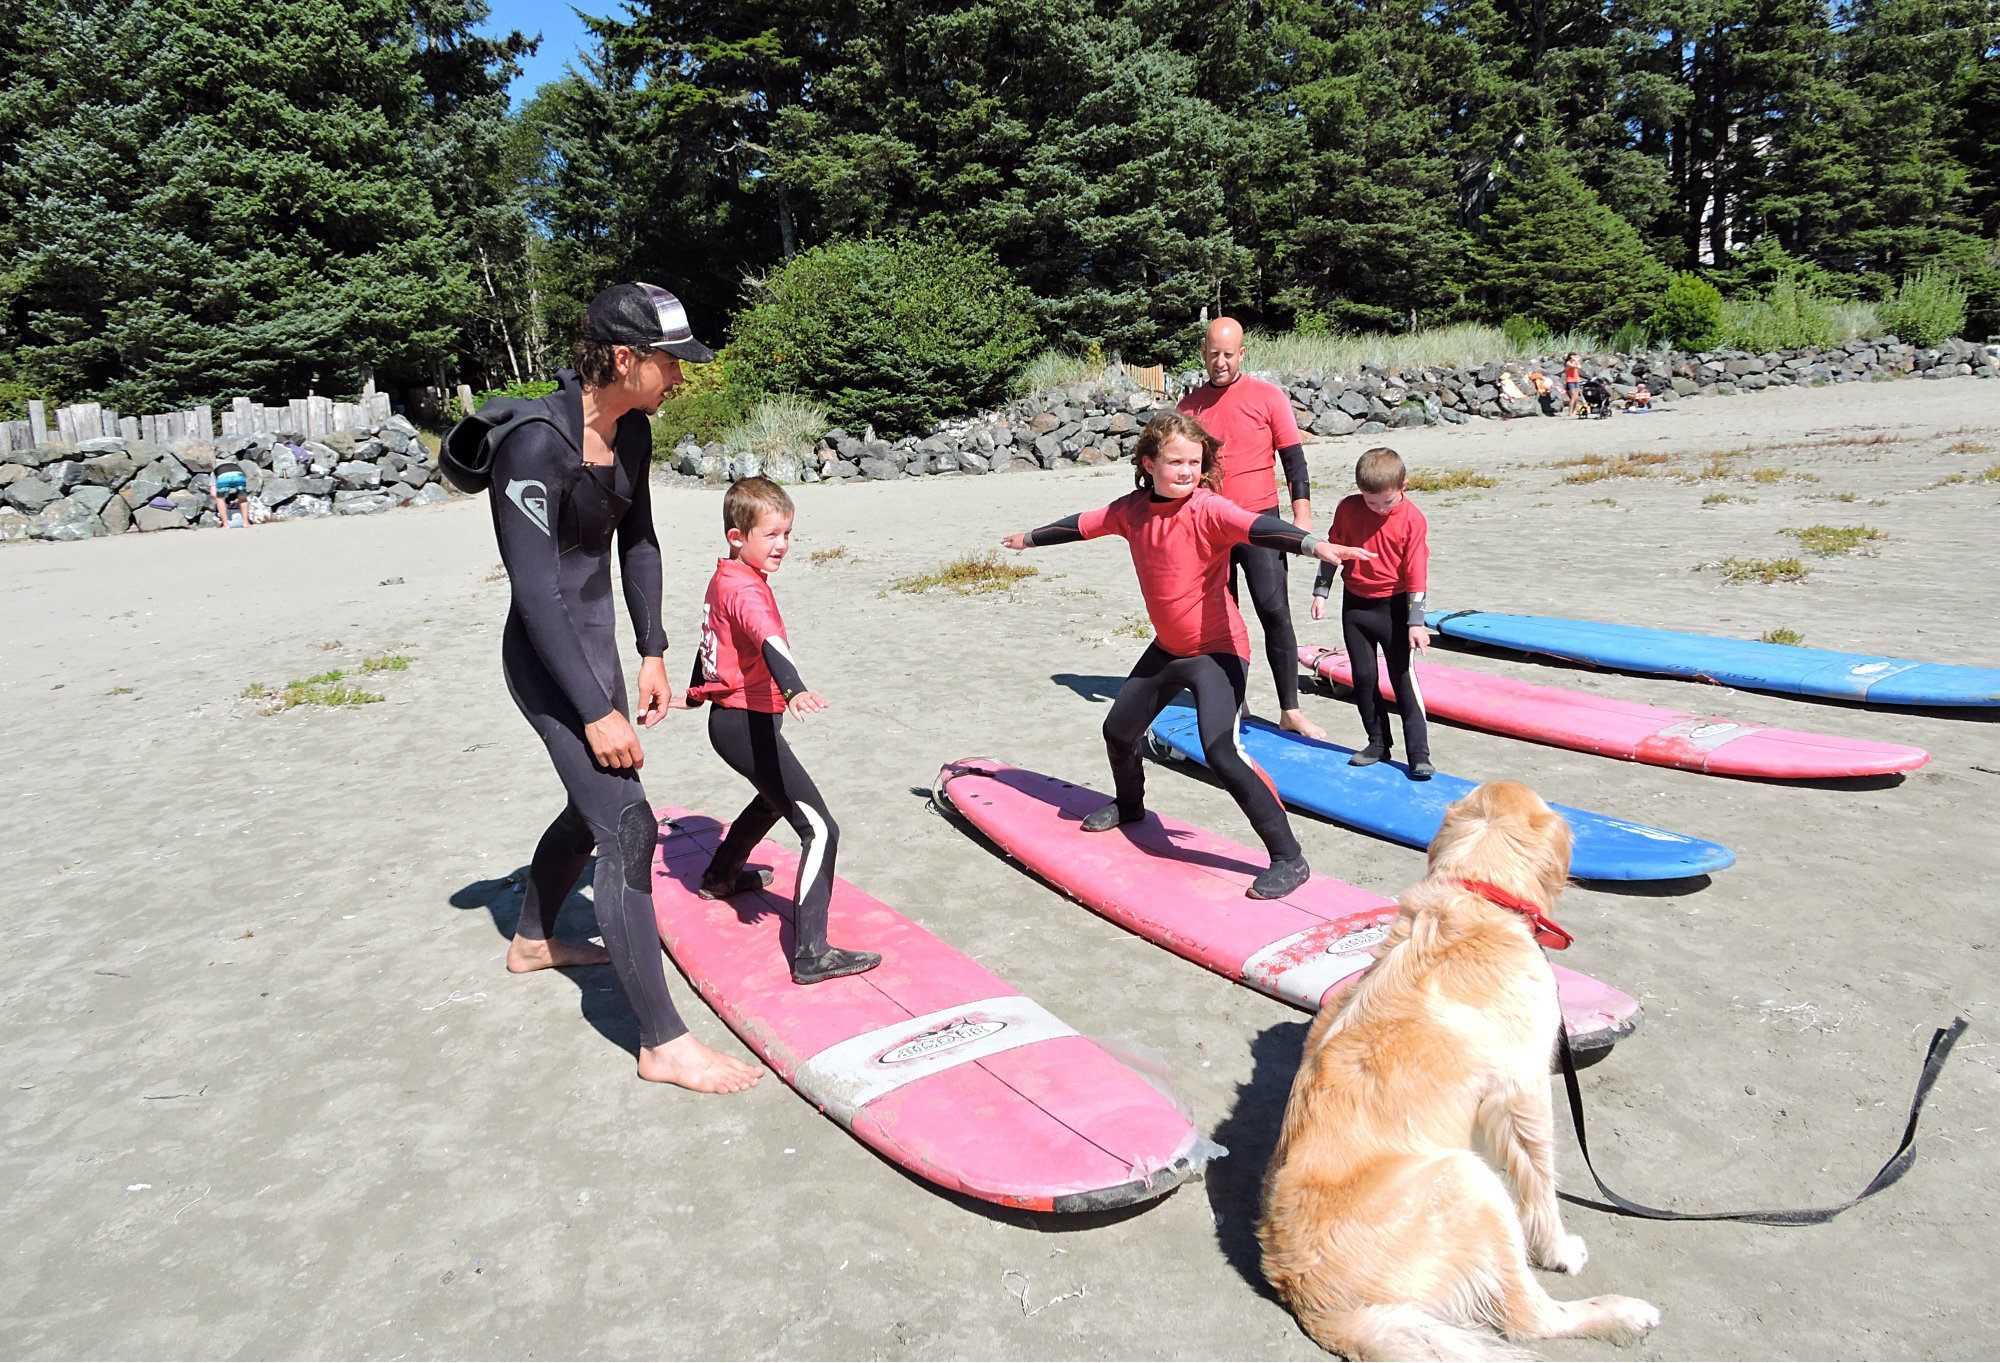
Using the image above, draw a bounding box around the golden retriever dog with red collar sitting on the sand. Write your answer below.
[1258,781,1660,1359]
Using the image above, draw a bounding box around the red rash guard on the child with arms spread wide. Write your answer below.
[1076,487,1256,658]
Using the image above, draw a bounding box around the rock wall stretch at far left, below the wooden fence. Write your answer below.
[0,416,452,542]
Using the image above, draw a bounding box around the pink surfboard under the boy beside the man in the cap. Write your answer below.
[652,809,1224,1211]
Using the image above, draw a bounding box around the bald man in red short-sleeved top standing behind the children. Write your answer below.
[1180,318,1326,737]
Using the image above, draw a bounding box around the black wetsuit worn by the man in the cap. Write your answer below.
[490,370,688,1047]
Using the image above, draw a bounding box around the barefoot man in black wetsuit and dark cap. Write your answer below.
[490,284,764,1093]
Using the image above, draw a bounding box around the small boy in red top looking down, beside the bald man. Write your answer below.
[1312,448,1436,781]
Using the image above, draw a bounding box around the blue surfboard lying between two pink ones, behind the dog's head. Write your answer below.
[1152,705,1736,879]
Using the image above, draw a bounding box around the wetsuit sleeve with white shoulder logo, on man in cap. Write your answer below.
[488,424,612,723]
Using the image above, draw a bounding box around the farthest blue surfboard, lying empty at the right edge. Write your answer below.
[1424,610,2000,705]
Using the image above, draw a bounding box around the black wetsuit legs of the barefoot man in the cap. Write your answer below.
[500,620,688,1047]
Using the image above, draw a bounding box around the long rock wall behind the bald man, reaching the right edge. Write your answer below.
[672,336,2000,484]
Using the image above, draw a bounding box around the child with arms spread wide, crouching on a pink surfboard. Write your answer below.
[1000,412,1362,899]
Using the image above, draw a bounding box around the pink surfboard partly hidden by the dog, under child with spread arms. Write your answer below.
[936,757,1638,1051]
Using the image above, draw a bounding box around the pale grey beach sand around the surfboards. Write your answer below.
[0,380,2000,1359]
